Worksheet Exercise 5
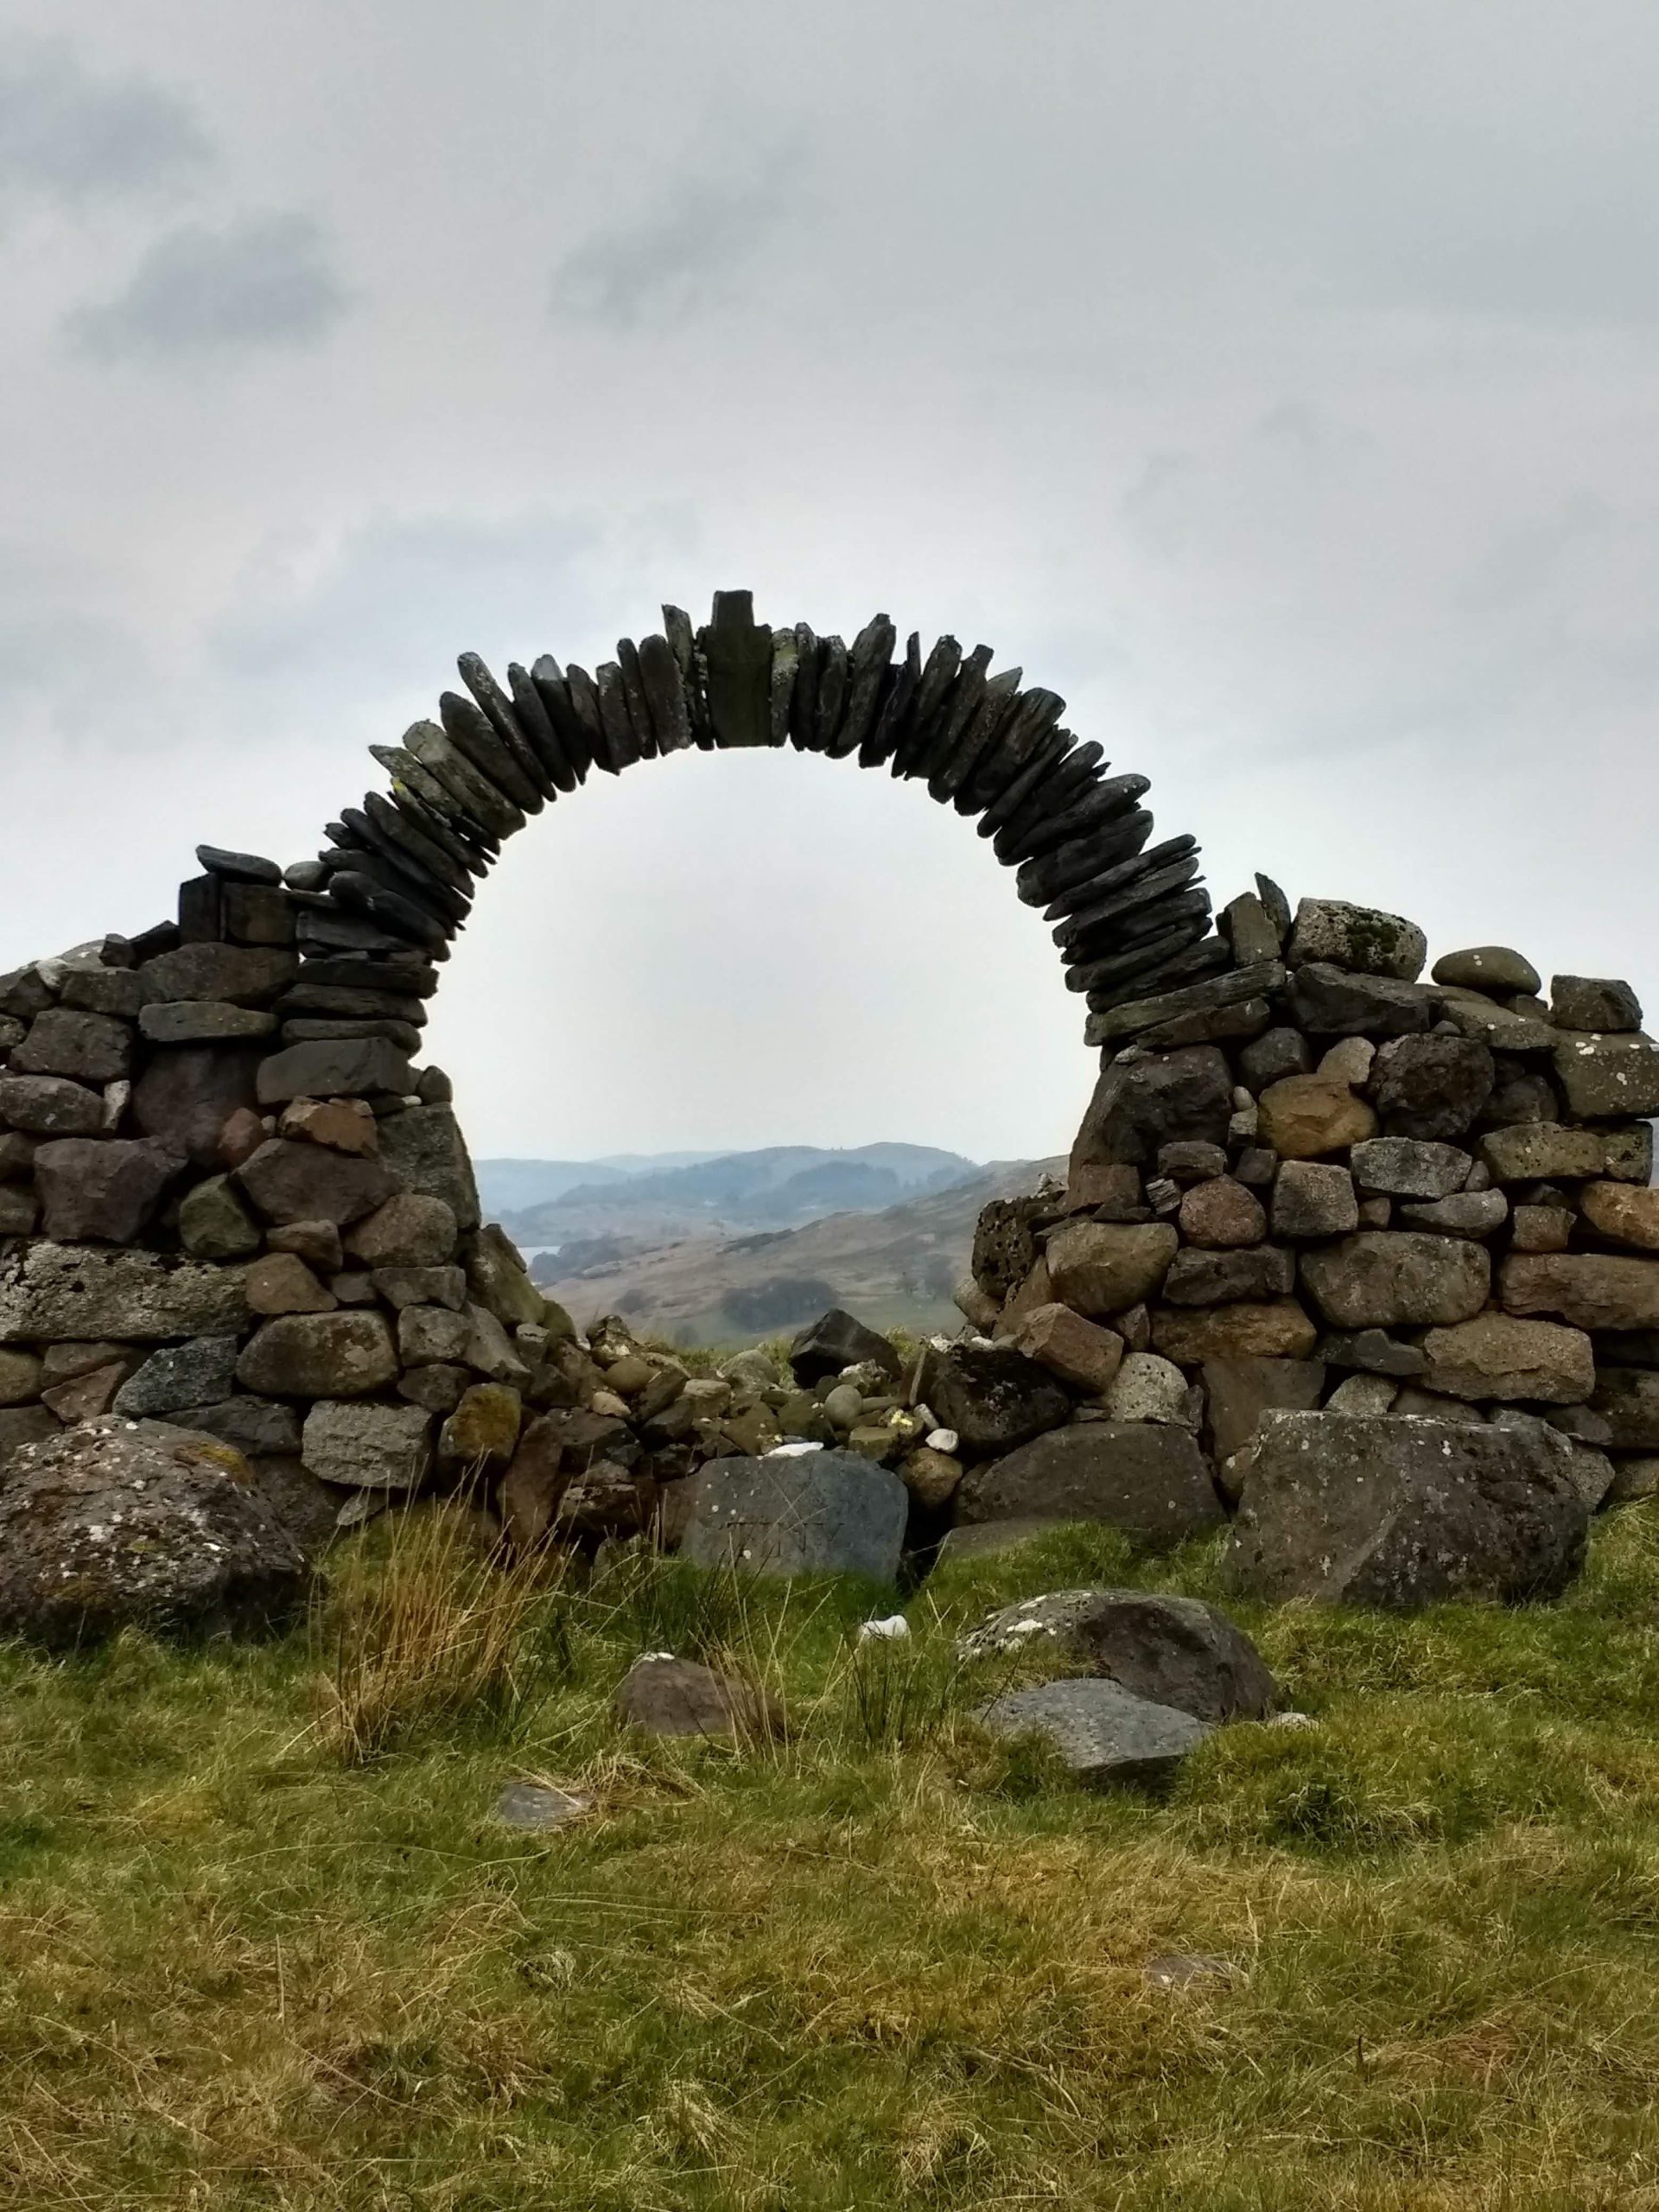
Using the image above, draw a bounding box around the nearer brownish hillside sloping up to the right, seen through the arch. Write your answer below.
[536,1148,1064,1344]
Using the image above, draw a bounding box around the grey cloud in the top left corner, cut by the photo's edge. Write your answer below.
[0,40,210,204]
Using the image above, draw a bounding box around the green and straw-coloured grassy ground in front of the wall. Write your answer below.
[0,1506,1659,2212]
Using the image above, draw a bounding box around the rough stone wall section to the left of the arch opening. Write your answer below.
[0,847,539,1522]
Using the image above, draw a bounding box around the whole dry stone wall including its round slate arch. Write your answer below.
[0,593,1659,1541]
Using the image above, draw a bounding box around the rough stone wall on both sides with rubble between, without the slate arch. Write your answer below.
[0,818,1659,1645]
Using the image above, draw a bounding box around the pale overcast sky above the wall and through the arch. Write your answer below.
[0,0,1659,1157]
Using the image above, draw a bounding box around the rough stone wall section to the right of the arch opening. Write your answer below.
[927,878,1659,1595]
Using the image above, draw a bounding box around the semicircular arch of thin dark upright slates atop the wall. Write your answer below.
[296,591,1230,1042]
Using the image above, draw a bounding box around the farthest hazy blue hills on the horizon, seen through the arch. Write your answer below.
[499,1144,980,1249]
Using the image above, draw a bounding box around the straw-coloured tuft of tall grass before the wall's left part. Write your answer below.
[309,1506,569,1765]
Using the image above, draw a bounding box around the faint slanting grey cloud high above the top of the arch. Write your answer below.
[549,150,798,329]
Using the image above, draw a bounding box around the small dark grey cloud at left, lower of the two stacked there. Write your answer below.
[64,214,349,360]
